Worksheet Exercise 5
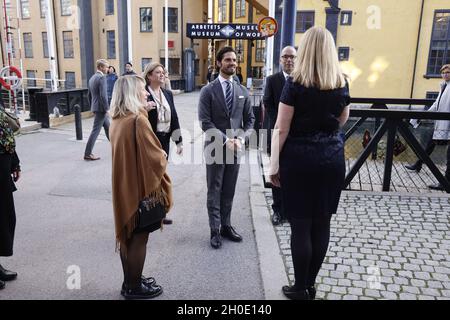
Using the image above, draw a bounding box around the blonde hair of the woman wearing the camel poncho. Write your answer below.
[111,75,145,119]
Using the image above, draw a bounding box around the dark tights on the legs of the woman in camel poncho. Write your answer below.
[120,232,148,289]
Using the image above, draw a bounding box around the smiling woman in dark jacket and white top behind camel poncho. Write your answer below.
[143,62,183,224]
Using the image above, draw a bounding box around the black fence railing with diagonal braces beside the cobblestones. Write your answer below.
[344,98,450,193]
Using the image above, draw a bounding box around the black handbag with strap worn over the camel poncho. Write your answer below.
[134,117,166,229]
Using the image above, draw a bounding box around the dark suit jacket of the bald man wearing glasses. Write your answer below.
[263,71,286,129]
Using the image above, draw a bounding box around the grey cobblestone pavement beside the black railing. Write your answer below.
[266,191,450,300]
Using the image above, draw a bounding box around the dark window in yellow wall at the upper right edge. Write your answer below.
[427,10,450,76]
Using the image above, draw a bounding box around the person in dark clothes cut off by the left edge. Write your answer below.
[0,106,20,289]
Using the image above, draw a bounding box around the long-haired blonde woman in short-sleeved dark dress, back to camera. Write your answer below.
[270,27,350,300]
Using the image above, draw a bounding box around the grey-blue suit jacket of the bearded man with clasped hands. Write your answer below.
[198,78,255,146]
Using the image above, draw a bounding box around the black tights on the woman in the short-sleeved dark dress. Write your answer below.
[290,215,331,290]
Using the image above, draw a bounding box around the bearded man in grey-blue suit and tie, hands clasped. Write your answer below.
[198,47,255,249]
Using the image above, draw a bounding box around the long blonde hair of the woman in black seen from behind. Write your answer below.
[291,27,346,90]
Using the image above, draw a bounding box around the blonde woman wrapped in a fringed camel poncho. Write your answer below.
[110,76,172,299]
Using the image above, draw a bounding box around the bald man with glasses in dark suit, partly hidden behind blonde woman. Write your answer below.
[263,46,297,226]
